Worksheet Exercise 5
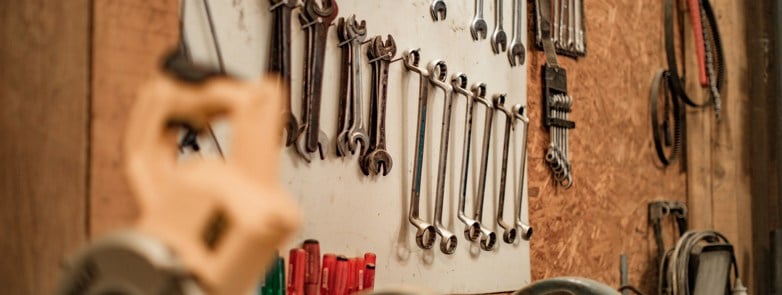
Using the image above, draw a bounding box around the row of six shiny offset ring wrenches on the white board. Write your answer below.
[402,48,532,254]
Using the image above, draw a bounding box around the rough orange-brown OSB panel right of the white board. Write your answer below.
[528,0,686,293]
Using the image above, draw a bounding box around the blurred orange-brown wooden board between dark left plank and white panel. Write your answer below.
[90,0,179,235]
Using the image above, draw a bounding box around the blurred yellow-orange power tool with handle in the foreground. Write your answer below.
[57,54,299,294]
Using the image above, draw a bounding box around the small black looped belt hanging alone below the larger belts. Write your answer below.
[649,70,683,166]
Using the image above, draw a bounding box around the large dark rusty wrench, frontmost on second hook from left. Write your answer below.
[303,0,339,159]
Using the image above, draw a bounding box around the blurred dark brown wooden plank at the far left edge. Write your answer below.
[0,0,90,294]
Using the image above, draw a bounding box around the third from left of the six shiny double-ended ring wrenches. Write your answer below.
[451,73,486,241]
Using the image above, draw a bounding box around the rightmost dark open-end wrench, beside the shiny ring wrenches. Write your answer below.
[364,35,396,176]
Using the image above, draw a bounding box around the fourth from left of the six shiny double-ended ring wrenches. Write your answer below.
[472,90,505,251]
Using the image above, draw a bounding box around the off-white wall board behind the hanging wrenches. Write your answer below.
[185,0,534,293]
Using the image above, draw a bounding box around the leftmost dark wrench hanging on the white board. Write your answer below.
[268,0,299,146]
